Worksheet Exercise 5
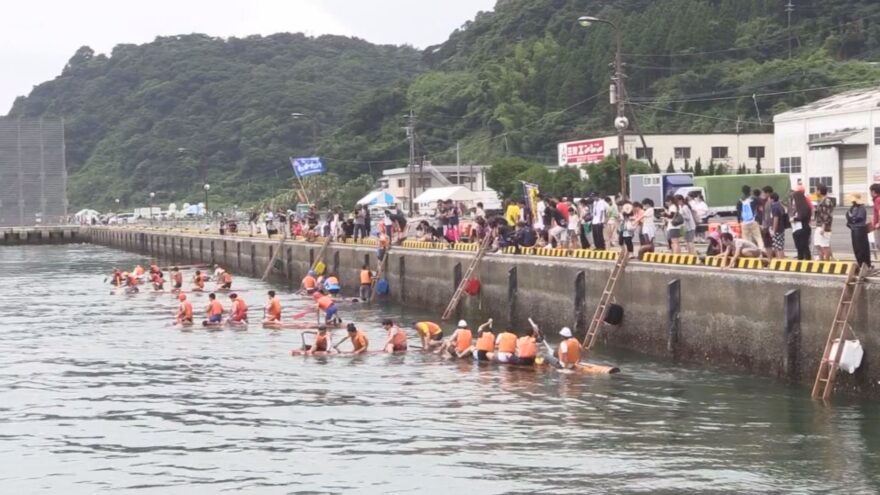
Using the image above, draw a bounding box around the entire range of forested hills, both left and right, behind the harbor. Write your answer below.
[11,0,880,207]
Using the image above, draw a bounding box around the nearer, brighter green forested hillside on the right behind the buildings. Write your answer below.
[326,0,880,170]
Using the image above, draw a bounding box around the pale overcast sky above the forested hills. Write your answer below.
[0,0,495,115]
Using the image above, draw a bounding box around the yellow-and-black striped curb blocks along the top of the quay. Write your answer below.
[99,225,853,275]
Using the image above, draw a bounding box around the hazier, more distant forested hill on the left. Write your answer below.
[10,34,421,208]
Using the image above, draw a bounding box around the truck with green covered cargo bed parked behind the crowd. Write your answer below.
[679,174,791,216]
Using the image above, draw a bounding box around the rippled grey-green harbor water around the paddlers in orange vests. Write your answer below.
[0,245,880,494]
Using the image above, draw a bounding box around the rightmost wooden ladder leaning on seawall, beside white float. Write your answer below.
[812,264,869,400]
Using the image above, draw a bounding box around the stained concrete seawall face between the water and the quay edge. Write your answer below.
[83,228,880,397]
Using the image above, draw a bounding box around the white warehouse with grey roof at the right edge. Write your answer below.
[773,88,880,204]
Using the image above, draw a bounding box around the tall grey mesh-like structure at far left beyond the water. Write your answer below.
[0,118,67,226]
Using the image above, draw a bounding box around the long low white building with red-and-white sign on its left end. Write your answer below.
[558,133,774,172]
